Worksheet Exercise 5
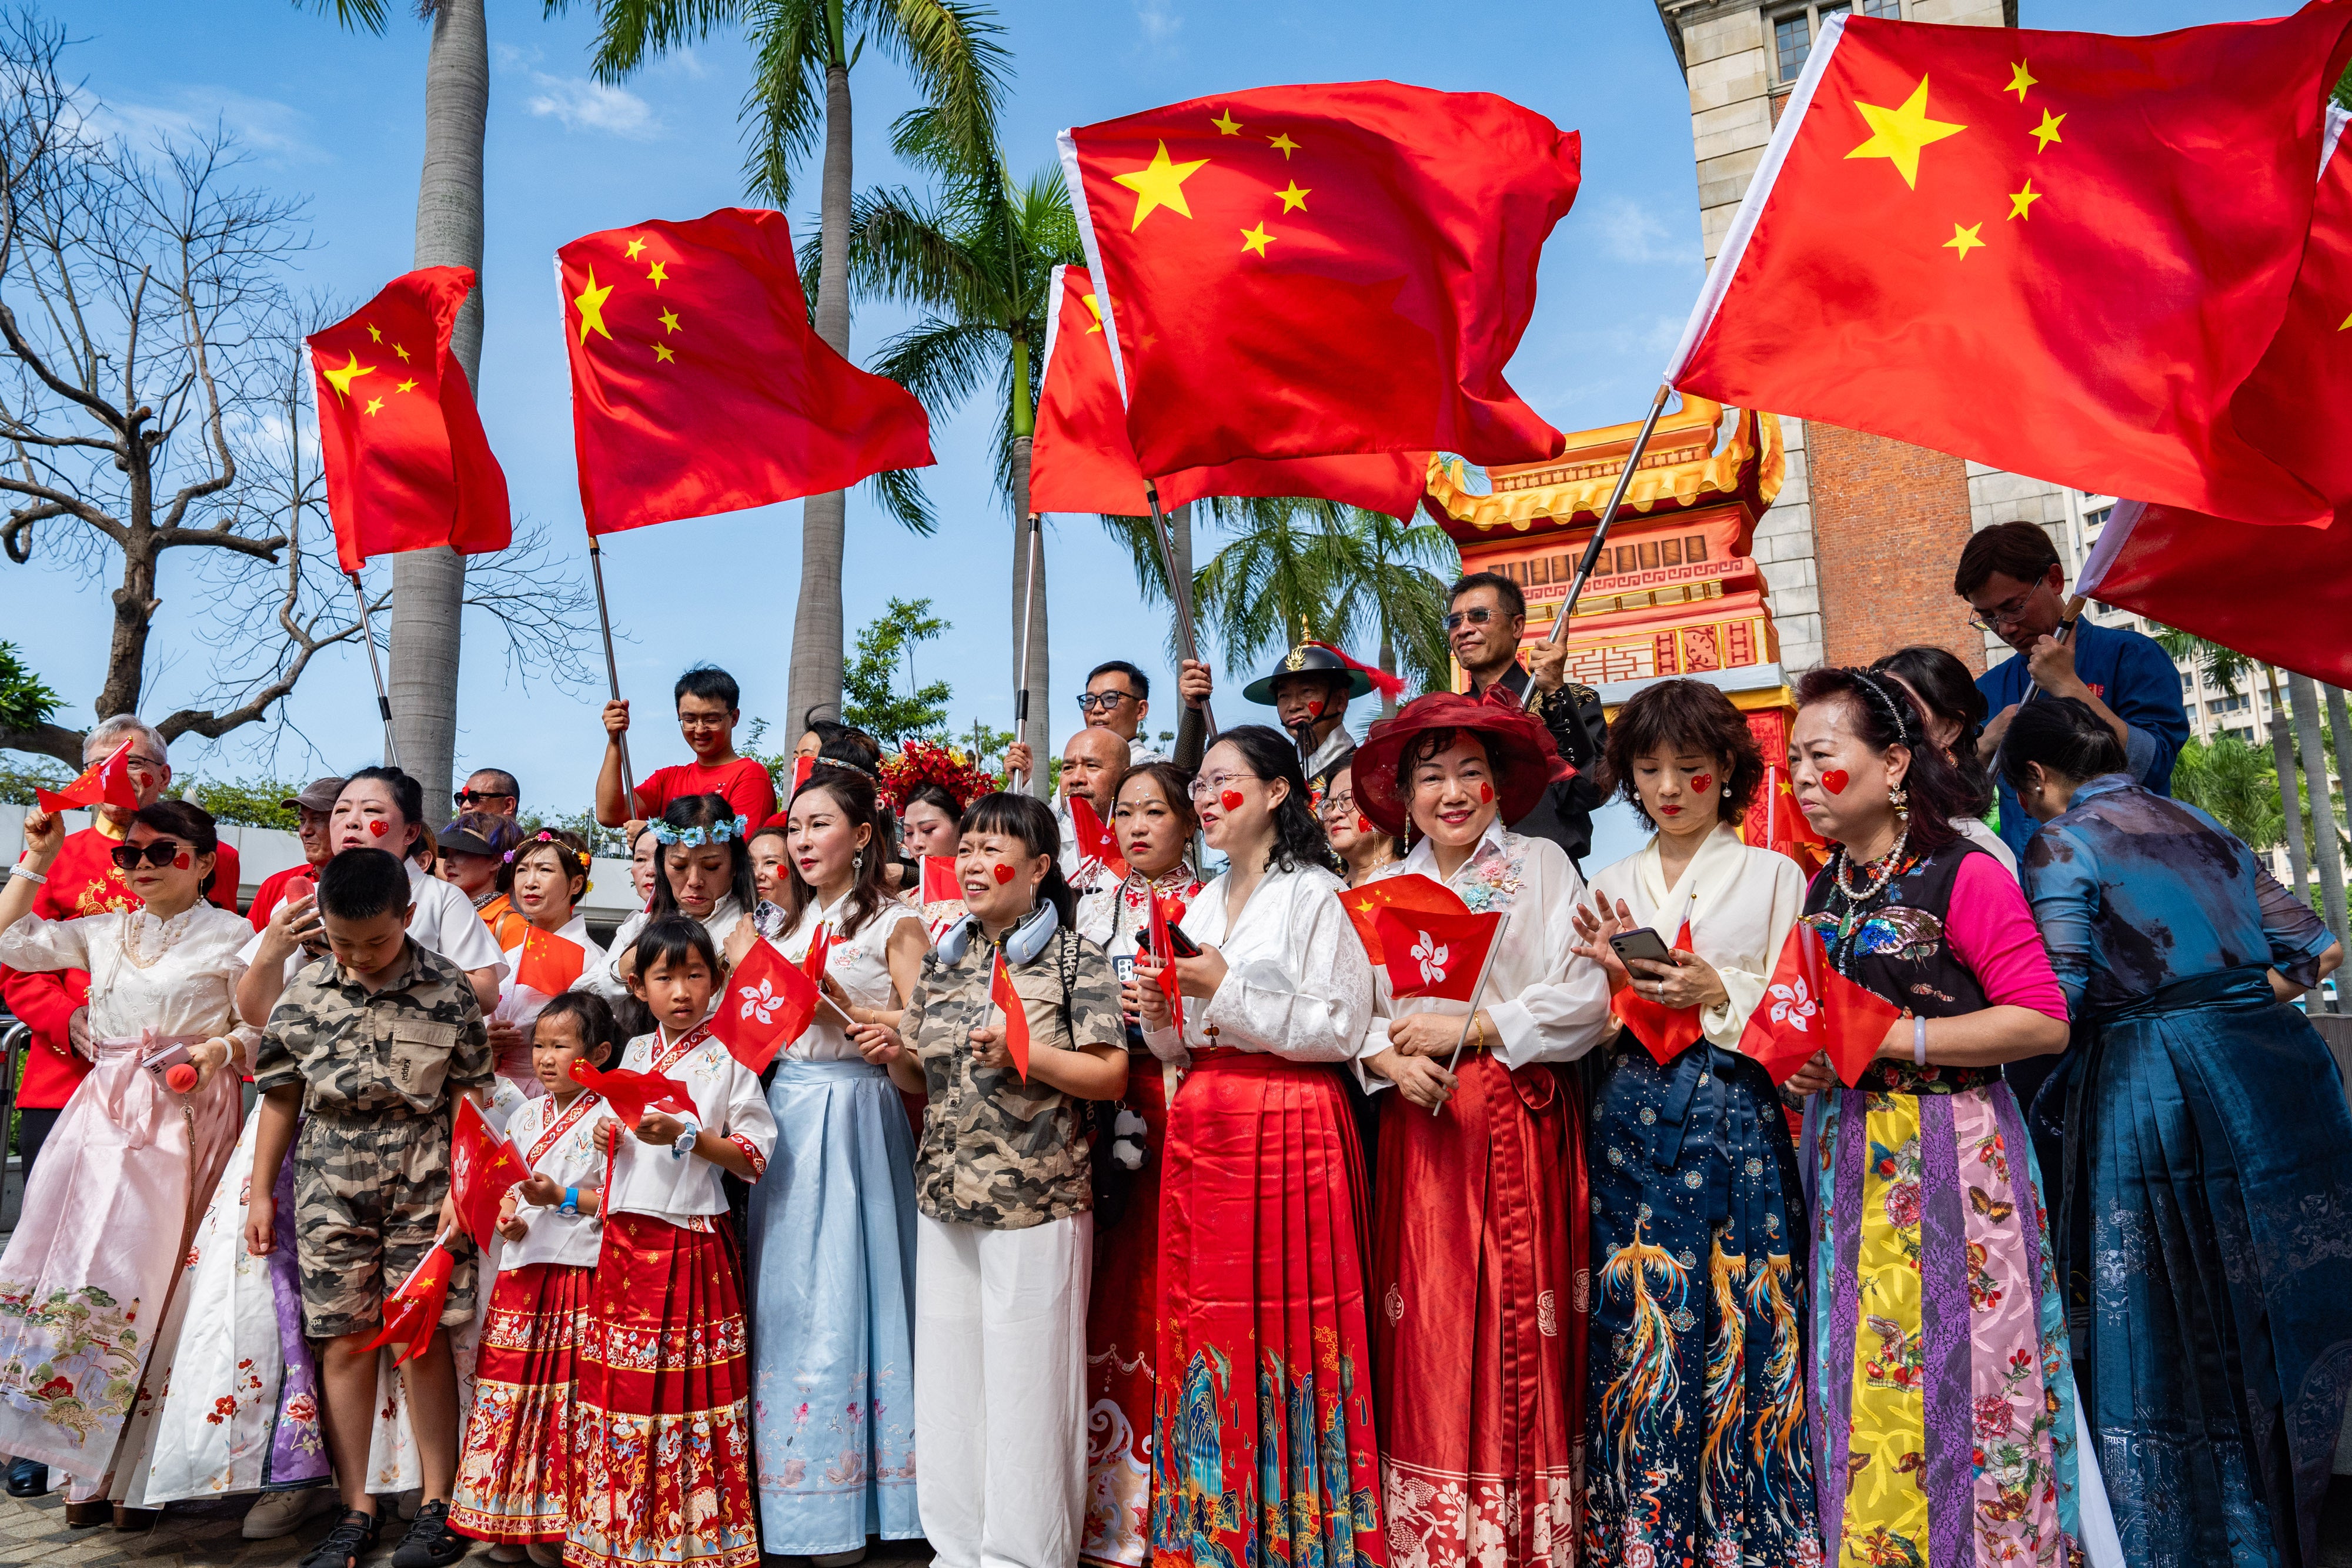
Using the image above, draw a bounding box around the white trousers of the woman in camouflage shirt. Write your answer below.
[915,1213,1094,1568]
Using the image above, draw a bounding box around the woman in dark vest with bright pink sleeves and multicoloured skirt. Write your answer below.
[1773,670,2112,1568]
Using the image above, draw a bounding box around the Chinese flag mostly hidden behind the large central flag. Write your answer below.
[1030,266,1430,517]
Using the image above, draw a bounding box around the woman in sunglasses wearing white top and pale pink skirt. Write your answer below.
[0,799,261,1523]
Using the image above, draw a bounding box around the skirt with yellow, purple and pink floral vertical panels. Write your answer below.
[1806,1084,2098,1568]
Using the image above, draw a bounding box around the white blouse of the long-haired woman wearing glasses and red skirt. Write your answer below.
[1143,865,1371,1062]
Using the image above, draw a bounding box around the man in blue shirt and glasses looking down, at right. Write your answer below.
[1952,522,2190,858]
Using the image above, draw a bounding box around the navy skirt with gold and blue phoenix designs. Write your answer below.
[1585,1037,1816,1566]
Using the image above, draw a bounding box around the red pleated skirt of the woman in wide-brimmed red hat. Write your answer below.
[1371,1053,1588,1568]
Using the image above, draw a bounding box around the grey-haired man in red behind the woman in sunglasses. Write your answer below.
[0,715,238,1180]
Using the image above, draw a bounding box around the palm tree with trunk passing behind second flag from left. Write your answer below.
[581,0,1007,724]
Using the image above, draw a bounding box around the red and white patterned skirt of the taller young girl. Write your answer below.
[564,1213,760,1568]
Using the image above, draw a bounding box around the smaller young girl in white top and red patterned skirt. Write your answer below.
[449,992,619,1568]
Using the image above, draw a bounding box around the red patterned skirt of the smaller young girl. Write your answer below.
[449,1262,595,1542]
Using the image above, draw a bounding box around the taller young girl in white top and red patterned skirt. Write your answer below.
[564,921,776,1568]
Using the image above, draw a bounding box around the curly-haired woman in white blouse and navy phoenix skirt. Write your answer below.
[1576,680,1820,1566]
